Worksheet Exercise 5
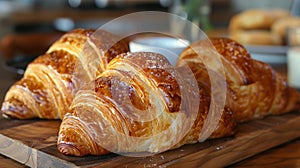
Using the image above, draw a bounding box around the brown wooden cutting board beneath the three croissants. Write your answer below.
[0,112,300,167]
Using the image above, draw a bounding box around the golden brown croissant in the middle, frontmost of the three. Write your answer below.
[57,52,235,156]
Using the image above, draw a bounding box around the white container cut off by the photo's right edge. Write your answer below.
[287,46,300,89]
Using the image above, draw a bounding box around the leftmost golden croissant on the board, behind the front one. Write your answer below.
[1,29,128,119]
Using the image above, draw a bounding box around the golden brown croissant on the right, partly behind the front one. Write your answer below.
[179,38,300,122]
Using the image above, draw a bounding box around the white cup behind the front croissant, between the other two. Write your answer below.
[129,37,190,66]
